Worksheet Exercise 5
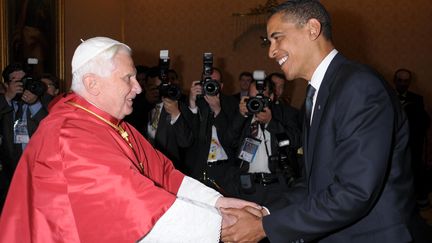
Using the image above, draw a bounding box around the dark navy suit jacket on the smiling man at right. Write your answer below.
[263,54,413,243]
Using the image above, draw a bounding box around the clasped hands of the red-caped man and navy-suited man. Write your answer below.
[215,197,269,242]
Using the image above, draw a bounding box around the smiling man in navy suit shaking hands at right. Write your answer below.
[222,0,414,243]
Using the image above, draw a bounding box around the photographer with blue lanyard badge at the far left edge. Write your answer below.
[0,63,48,209]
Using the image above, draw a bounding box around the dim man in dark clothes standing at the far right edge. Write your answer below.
[393,68,430,208]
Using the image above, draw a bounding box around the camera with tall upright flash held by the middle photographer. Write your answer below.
[201,52,220,96]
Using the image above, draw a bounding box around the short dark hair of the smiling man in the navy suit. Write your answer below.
[271,0,333,40]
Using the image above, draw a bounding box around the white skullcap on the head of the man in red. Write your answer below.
[72,37,130,73]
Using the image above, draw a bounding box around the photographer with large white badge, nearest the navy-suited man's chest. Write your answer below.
[229,78,301,206]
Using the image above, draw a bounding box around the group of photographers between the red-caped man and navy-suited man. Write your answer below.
[125,51,302,205]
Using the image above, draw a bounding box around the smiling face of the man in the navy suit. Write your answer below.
[267,13,317,80]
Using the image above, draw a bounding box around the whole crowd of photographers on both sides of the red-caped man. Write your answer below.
[0,51,302,211]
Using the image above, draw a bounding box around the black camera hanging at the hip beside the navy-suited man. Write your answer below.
[268,133,299,186]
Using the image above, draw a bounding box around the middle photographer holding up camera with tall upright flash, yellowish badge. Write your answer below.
[185,65,237,195]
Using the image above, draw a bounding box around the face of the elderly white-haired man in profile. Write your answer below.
[96,51,141,119]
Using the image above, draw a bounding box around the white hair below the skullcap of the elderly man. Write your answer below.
[71,44,131,94]
